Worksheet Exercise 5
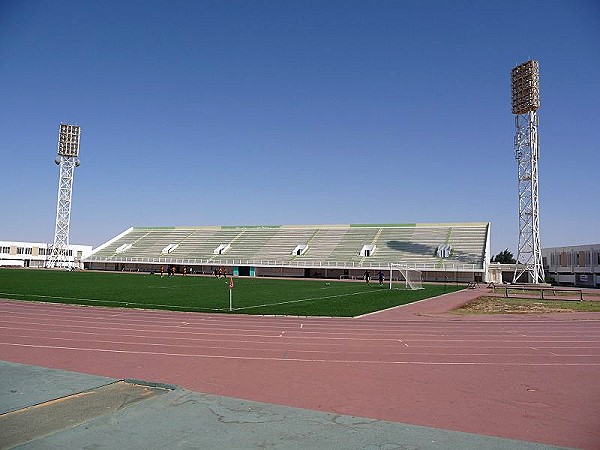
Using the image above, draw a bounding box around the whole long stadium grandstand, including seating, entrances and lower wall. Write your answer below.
[84,222,490,282]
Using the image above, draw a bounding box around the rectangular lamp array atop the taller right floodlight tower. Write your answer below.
[510,60,540,114]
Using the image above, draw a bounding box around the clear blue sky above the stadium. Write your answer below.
[0,0,600,253]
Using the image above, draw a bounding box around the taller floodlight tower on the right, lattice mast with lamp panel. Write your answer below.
[511,61,544,284]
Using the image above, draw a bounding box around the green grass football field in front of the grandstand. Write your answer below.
[0,269,462,317]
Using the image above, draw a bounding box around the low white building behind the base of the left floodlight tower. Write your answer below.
[0,241,92,269]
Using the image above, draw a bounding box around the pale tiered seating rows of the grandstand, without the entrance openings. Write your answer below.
[88,223,488,269]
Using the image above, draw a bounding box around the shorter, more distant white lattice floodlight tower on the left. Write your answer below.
[46,123,81,268]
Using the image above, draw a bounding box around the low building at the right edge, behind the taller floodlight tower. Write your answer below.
[542,244,600,287]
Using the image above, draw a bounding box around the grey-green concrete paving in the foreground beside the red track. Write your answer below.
[0,361,572,450]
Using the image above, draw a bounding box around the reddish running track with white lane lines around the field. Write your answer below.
[0,291,600,449]
